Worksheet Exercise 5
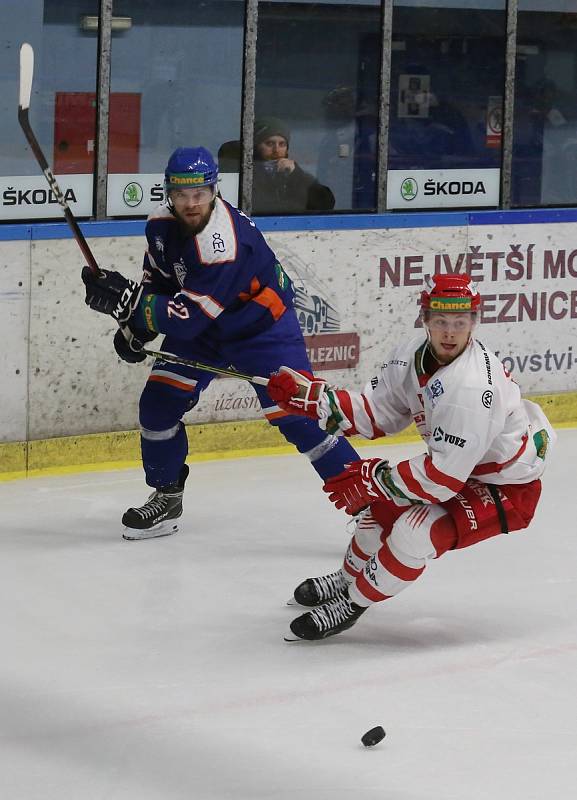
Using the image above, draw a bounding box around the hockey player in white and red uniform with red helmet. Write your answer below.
[268,274,556,640]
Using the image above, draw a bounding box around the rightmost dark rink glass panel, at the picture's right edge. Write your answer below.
[512,0,577,207]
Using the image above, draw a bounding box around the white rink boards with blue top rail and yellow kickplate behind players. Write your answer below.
[0,210,577,477]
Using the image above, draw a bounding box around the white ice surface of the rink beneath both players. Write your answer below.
[0,430,577,800]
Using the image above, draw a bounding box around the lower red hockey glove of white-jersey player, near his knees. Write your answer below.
[323,458,391,516]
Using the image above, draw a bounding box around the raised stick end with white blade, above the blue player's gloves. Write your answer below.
[18,43,101,275]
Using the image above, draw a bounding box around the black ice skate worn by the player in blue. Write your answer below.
[122,464,188,541]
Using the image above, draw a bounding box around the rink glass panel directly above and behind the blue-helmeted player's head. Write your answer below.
[108,0,245,209]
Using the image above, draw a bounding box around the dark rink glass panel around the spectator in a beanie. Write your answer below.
[255,2,382,213]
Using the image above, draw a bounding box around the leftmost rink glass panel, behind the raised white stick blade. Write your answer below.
[0,0,98,221]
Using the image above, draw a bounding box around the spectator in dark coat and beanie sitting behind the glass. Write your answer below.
[252,117,335,214]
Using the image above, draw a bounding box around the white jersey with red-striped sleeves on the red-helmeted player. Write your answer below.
[329,337,556,503]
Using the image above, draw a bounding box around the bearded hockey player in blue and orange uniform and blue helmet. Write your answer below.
[82,147,358,539]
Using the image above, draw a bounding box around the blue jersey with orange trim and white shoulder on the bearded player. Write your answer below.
[132,198,294,341]
